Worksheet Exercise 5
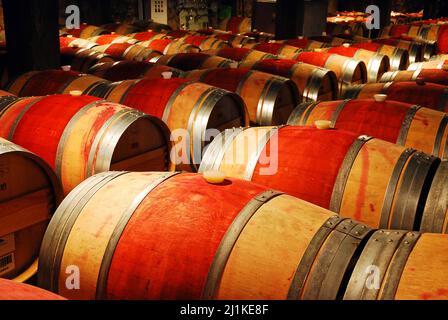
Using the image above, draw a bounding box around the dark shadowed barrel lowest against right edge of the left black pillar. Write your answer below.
[61,47,115,73]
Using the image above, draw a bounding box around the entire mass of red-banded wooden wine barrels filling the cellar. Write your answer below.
[0,13,448,300]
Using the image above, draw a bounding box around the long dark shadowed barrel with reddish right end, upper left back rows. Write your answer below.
[89,60,182,82]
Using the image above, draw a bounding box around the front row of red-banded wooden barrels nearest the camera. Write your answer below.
[0,140,448,300]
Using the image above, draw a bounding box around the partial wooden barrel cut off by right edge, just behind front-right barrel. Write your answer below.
[421,162,448,233]
